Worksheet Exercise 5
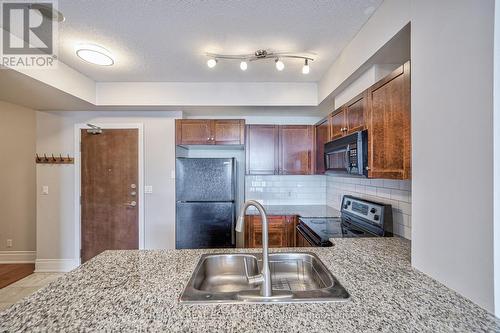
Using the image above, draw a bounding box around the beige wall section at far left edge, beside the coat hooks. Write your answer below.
[0,101,36,262]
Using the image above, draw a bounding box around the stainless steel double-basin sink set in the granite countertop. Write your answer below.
[180,252,349,304]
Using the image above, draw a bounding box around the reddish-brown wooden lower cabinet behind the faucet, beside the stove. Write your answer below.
[245,215,298,248]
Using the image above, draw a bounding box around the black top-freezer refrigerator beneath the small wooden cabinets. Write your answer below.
[175,157,236,249]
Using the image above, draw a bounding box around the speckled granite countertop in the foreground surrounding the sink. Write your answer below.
[0,237,500,332]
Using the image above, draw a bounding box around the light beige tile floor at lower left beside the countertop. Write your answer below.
[0,273,63,311]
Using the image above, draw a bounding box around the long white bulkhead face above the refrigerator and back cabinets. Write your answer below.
[96,82,318,106]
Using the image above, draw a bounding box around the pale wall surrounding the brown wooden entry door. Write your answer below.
[37,111,180,269]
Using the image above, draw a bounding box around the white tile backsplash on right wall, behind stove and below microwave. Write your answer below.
[326,176,411,239]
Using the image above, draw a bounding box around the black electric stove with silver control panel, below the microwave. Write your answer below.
[297,195,392,247]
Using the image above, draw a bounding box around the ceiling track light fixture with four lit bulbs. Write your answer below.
[206,50,314,75]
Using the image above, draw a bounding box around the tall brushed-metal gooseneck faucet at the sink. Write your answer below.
[235,200,272,297]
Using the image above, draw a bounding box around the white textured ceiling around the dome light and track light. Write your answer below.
[55,0,382,82]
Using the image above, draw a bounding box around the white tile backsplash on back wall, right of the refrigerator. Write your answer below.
[245,175,326,205]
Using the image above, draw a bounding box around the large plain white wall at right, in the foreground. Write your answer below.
[411,0,494,312]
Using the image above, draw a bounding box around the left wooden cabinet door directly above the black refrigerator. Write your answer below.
[175,119,212,145]
